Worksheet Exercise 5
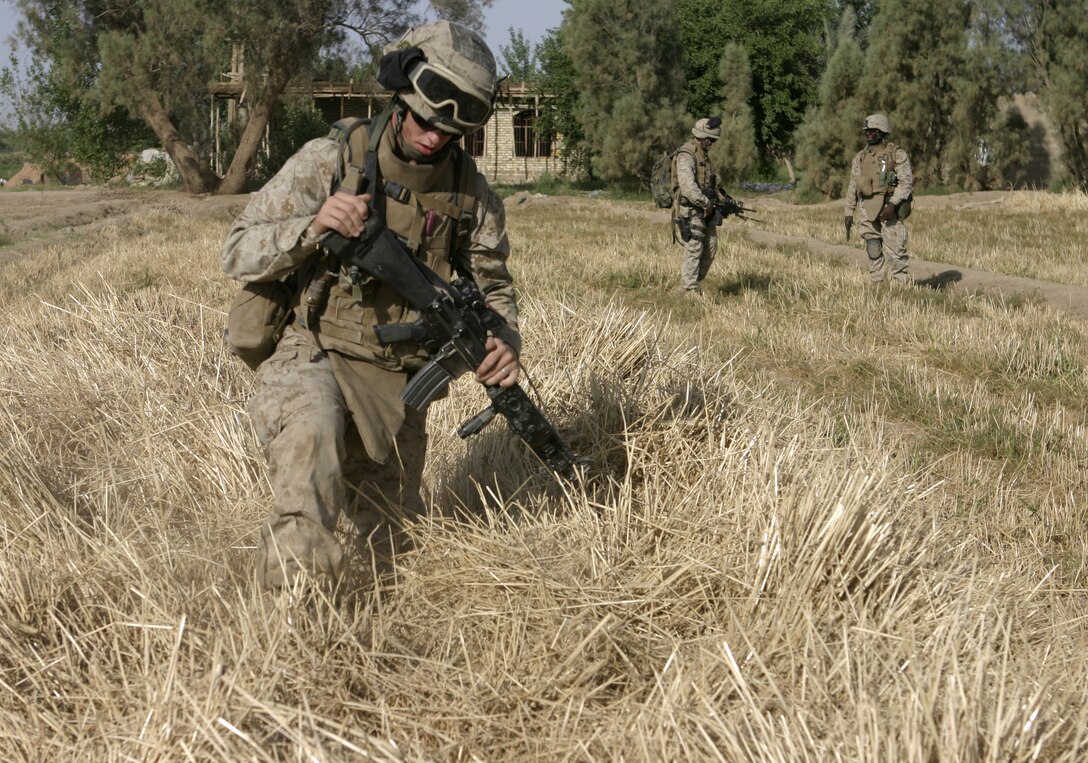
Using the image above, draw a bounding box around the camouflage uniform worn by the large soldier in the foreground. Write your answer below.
[222,124,520,588]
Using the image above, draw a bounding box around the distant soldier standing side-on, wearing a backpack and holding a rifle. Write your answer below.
[672,116,721,294]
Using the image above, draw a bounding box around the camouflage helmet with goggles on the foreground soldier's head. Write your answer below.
[378,21,497,135]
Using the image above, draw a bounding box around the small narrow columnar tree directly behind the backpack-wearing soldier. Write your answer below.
[710,42,757,185]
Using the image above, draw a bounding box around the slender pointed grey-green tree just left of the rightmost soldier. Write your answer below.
[796,8,865,198]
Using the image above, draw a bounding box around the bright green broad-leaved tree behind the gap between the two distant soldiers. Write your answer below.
[676,0,837,175]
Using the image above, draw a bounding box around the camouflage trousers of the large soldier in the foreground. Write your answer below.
[249,334,426,588]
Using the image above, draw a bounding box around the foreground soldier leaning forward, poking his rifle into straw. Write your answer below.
[222,22,520,589]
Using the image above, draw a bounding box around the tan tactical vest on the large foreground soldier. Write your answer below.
[304,113,477,371]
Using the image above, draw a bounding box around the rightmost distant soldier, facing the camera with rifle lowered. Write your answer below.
[843,114,914,283]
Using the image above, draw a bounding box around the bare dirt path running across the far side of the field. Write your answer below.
[6,187,1088,320]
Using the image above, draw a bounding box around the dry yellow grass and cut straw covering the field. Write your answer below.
[0,186,1088,763]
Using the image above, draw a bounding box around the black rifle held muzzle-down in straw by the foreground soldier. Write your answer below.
[321,211,586,475]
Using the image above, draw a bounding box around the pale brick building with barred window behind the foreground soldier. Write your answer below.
[211,82,573,184]
